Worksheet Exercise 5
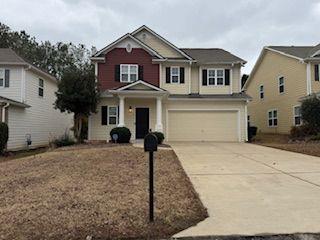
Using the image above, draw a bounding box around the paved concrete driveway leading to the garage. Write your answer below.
[171,143,320,237]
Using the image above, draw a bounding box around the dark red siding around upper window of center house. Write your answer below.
[98,48,159,90]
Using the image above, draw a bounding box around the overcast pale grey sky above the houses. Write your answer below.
[0,0,320,73]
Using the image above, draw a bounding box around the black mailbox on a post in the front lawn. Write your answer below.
[144,133,158,222]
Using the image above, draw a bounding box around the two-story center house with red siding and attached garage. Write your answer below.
[88,26,249,142]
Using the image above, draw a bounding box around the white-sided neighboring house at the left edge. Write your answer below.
[0,48,72,150]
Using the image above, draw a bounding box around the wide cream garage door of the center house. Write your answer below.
[168,110,239,142]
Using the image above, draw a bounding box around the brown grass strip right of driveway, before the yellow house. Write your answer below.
[253,134,320,157]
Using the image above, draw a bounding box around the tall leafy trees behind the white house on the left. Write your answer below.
[0,22,94,79]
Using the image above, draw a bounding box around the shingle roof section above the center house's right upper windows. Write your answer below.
[181,48,246,64]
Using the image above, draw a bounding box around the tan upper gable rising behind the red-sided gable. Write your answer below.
[131,25,193,60]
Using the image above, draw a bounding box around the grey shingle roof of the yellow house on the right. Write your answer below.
[268,44,320,59]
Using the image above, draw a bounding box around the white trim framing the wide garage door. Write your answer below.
[166,108,241,142]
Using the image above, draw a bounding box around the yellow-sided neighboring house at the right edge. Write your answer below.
[244,44,320,134]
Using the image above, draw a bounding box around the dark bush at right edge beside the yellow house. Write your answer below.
[301,96,320,133]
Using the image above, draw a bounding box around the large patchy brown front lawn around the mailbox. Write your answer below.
[0,146,207,240]
